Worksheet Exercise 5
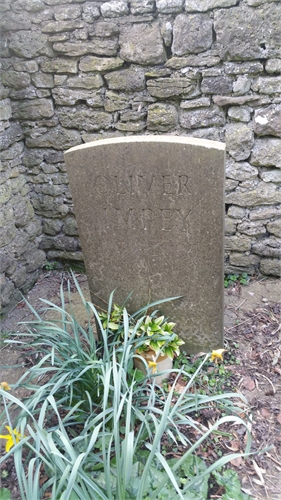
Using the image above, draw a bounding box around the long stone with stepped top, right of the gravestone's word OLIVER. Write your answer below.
[225,182,281,207]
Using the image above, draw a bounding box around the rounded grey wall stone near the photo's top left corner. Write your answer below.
[10,31,54,59]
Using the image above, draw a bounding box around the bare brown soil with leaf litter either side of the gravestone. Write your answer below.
[0,271,281,500]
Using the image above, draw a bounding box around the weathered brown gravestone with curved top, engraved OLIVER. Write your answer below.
[65,135,225,353]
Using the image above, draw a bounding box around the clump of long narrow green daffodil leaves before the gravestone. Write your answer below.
[0,279,258,500]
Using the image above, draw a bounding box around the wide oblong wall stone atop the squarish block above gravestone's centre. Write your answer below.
[147,77,197,98]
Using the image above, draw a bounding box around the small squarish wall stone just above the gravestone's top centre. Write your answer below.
[147,103,178,132]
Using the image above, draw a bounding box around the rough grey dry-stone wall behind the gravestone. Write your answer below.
[0,0,281,305]
